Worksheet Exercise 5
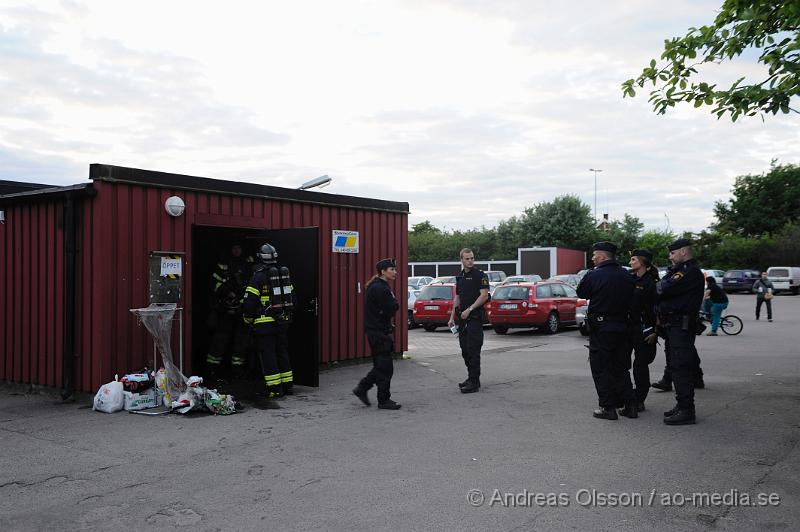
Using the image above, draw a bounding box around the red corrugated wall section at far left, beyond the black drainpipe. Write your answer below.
[0,201,64,386]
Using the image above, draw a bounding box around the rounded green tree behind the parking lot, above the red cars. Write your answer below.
[518,194,594,249]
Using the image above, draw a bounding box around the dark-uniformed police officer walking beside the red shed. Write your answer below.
[353,259,400,410]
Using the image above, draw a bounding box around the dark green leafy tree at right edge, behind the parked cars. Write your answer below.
[714,161,800,236]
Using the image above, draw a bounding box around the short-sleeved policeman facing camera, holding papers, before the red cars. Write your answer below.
[448,248,489,393]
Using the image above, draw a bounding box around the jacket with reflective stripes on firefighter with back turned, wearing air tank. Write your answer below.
[242,264,295,332]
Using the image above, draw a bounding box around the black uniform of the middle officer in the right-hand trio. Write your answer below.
[629,272,656,411]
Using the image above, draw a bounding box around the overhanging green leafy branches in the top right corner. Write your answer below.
[622,0,800,122]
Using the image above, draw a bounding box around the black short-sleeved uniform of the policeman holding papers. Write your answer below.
[455,268,489,393]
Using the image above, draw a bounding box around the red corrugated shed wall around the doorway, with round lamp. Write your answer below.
[76,181,408,391]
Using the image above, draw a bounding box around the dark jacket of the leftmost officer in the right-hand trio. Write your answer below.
[578,260,633,331]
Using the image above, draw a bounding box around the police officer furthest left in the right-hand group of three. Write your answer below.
[578,242,638,419]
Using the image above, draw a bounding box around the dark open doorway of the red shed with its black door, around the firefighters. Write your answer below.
[191,226,319,386]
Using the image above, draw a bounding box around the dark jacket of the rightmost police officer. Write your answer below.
[656,259,705,319]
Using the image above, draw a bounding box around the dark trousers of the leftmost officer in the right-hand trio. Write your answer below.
[589,330,634,408]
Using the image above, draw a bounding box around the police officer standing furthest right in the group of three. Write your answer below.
[656,238,705,425]
